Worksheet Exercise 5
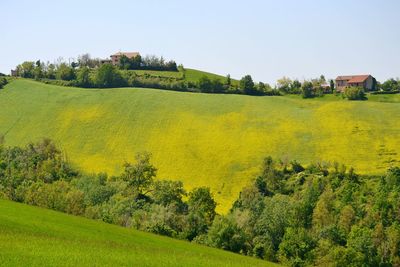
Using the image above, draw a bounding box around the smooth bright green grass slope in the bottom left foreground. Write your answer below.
[0,200,278,266]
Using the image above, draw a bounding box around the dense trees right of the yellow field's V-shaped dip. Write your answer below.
[204,157,400,266]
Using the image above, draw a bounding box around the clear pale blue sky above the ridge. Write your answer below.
[0,0,400,84]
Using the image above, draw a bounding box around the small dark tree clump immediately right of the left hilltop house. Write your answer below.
[118,55,178,71]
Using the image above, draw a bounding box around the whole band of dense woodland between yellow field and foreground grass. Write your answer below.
[0,140,400,266]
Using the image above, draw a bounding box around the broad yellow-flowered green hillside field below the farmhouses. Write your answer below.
[0,79,400,212]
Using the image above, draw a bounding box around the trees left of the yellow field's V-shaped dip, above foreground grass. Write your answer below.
[0,139,216,243]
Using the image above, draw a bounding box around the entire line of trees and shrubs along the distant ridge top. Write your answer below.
[10,54,400,100]
